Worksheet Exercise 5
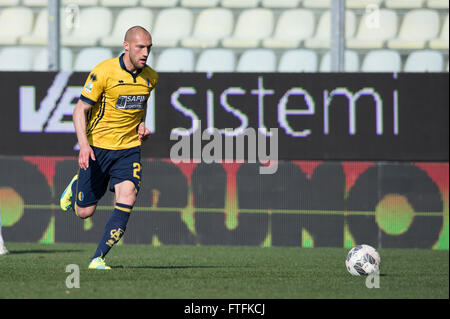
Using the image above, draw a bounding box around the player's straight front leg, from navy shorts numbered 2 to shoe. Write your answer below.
[90,148,141,269]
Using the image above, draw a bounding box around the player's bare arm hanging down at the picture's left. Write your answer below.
[73,99,95,170]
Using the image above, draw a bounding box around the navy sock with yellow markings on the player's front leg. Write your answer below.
[92,203,133,259]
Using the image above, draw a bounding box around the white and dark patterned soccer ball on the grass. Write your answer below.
[345,245,381,276]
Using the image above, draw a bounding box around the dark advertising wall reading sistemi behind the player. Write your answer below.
[0,72,449,249]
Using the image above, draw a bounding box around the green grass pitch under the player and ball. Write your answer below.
[0,243,449,299]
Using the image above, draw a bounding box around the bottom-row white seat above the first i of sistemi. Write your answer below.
[195,48,236,72]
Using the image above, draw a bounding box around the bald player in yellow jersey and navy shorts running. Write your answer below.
[60,26,158,269]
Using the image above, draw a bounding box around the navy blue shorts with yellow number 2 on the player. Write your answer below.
[76,146,142,207]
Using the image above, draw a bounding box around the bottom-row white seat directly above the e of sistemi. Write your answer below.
[278,49,318,72]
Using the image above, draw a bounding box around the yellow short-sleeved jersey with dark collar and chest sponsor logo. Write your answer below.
[80,54,158,150]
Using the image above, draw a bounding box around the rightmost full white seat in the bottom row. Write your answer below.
[403,50,444,72]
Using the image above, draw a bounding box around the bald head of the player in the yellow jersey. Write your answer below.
[123,26,152,72]
